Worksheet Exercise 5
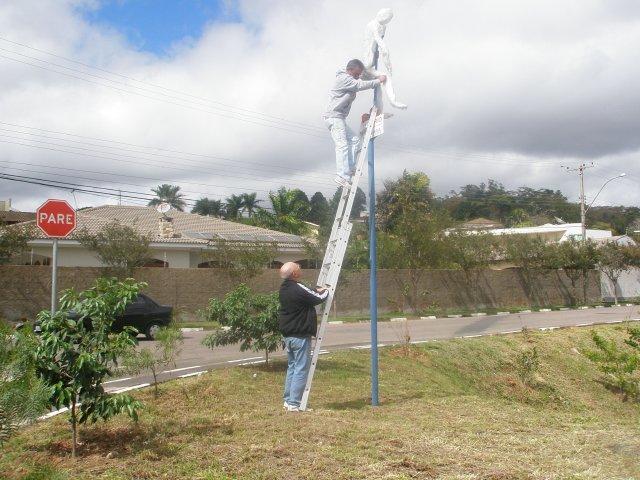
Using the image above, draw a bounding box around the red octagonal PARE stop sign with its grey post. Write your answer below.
[36,199,76,315]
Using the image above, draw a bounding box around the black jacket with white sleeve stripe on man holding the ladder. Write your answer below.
[278,279,329,337]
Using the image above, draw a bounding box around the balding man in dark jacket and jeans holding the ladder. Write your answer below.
[278,262,329,412]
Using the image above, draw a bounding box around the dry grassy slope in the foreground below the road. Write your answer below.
[0,327,640,480]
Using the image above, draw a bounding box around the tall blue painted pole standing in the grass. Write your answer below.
[367,55,381,407]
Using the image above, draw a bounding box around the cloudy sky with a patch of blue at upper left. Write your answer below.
[0,0,640,210]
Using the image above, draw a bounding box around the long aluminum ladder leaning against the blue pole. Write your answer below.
[300,107,378,410]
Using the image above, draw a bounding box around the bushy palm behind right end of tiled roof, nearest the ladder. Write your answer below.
[254,187,309,235]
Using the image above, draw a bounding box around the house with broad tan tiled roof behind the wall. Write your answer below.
[13,205,308,268]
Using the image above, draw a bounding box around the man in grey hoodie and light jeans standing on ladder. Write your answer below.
[323,59,387,187]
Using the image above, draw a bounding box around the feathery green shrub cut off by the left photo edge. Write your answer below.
[0,322,49,446]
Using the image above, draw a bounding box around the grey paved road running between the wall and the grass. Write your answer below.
[106,305,640,392]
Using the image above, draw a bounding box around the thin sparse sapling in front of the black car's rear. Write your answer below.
[123,327,183,397]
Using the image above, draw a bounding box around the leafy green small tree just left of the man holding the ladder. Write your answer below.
[202,283,282,364]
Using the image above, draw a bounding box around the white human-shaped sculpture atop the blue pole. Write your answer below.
[362,8,407,112]
